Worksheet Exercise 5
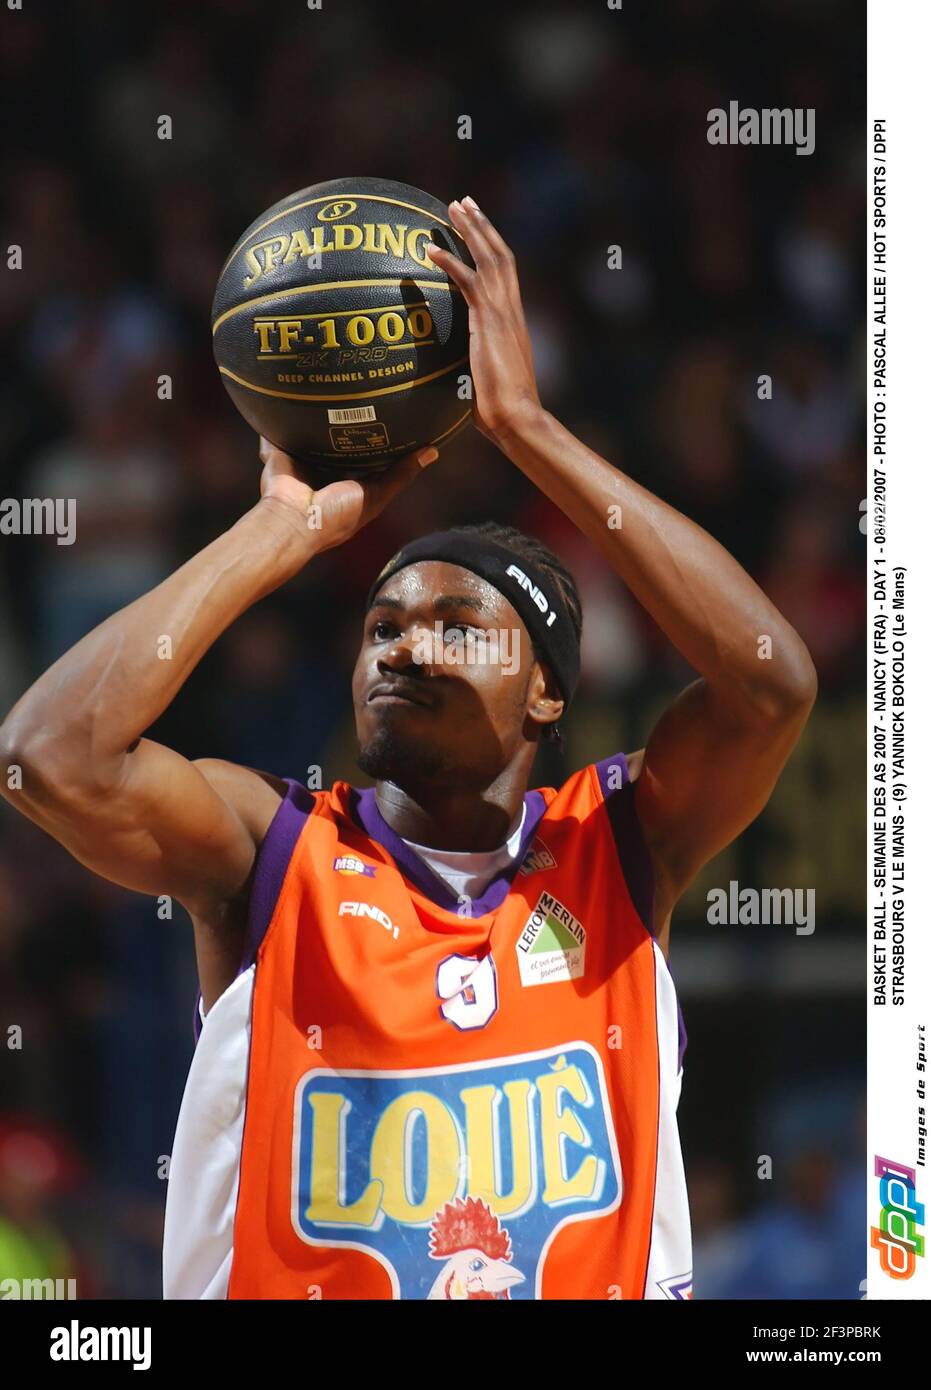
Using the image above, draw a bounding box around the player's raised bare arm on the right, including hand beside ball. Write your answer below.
[429,199,817,934]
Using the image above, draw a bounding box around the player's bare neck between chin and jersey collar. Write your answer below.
[375,770,527,851]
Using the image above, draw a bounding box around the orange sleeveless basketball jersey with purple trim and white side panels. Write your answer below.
[165,756,691,1298]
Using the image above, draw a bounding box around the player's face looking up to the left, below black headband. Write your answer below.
[353,560,543,787]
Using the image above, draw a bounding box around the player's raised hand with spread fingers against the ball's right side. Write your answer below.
[427,197,541,441]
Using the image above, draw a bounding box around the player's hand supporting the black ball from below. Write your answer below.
[258,439,439,552]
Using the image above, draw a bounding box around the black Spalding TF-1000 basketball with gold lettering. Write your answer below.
[213,178,471,478]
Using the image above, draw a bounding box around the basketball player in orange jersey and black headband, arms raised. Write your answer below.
[3,199,816,1300]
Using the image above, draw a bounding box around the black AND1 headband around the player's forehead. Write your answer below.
[365,531,579,706]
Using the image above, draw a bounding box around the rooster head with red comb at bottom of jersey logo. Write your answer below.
[427,1197,524,1298]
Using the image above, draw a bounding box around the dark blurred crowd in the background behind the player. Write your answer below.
[0,0,866,1298]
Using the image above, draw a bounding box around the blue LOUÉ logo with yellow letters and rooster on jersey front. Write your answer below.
[292,1043,623,1298]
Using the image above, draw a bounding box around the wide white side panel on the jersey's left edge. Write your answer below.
[163,966,256,1298]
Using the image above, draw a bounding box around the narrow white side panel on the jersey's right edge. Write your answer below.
[643,941,692,1300]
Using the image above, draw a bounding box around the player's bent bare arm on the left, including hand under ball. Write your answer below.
[0,446,436,994]
